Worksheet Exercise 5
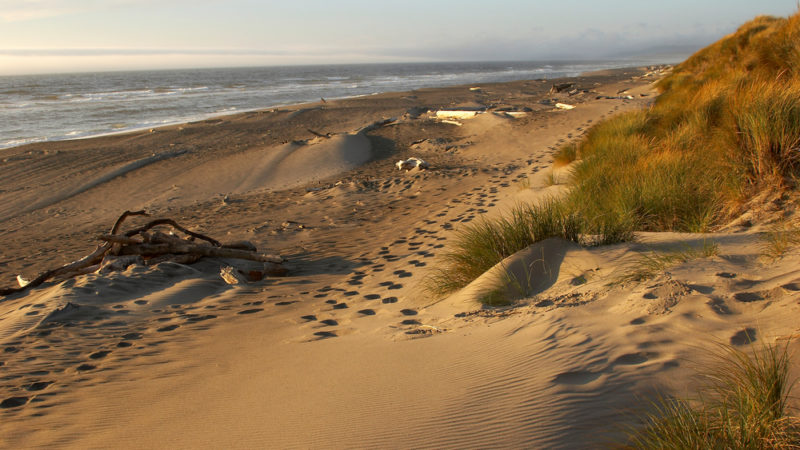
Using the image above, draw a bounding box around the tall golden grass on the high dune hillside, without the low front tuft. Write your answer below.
[559,13,800,232]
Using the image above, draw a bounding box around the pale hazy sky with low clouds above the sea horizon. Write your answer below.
[0,0,798,74]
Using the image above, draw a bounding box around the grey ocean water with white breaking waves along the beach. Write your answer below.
[0,59,659,149]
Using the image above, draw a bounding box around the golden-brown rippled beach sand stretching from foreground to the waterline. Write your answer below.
[0,70,800,448]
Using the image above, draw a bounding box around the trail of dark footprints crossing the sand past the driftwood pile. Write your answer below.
[0,121,591,408]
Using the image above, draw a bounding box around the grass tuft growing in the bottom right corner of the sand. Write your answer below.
[629,345,800,449]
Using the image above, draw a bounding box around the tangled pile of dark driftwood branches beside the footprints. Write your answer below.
[0,211,286,296]
